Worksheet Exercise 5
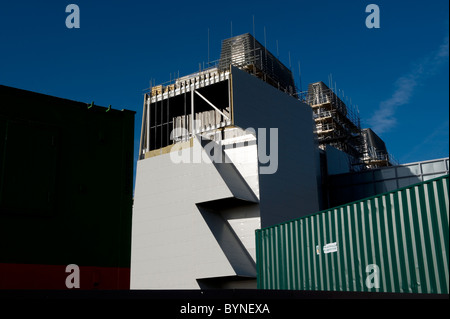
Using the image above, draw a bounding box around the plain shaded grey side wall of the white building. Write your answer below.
[232,68,319,227]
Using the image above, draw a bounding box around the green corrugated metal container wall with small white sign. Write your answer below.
[256,175,449,294]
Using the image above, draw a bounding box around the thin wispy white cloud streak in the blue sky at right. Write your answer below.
[368,36,449,134]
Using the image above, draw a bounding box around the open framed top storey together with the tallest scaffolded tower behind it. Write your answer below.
[139,33,298,159]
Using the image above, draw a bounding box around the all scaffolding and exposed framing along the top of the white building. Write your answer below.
[139,33,397,170]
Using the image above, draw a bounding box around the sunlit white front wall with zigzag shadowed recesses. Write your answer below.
[131,132,260,289]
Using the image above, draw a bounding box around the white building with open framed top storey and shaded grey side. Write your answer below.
[131,35,320,289]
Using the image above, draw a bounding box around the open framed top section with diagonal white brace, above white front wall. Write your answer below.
[139,68,232,159]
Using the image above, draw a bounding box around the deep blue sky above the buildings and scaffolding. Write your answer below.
[0,0,449,178]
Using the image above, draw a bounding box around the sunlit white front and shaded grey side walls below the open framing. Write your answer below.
[131,68,319,289]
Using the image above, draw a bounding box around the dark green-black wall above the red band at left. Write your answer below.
[0,86,134,267]
